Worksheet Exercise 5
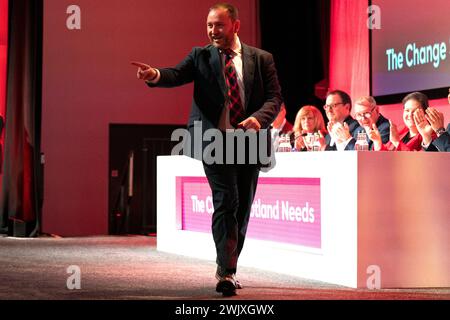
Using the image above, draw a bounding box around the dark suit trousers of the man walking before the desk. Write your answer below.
[203,163,259,273]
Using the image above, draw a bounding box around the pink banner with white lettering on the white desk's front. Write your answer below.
[176,177,321,248]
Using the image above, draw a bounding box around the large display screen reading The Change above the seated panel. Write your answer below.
[369,0,450,100]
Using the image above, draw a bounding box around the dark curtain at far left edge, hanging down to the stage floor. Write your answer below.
[0,0,43,236]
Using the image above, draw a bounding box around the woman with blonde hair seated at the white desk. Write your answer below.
[294,105,327,151]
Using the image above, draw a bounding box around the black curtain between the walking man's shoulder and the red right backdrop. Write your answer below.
[259,0,330,123]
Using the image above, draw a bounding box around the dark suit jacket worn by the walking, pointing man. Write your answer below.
[148,43,282,162]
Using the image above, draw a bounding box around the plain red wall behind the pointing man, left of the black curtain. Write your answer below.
[42,0,257,236]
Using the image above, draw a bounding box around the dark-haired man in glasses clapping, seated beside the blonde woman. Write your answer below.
[323,90,359,151]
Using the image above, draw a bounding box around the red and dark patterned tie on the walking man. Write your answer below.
[223,49,244,128]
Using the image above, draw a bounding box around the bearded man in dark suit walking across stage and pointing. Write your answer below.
[133,3,282,296]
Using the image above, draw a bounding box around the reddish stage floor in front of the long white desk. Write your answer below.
[0,236,450,300]
